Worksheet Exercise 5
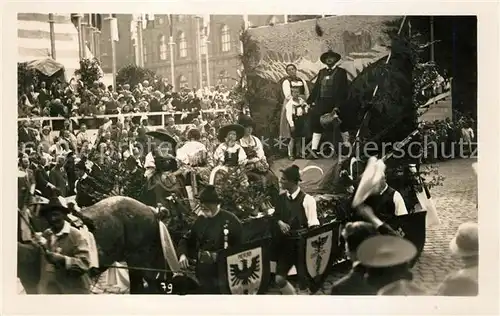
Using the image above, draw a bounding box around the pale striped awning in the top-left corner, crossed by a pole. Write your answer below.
[17,13,93,80]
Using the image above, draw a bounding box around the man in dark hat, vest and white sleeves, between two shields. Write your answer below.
[273,165,319,294]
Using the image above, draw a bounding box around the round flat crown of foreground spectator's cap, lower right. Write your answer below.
[356,235,418,268]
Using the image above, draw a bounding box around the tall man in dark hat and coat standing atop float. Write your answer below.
[307,50,349,154]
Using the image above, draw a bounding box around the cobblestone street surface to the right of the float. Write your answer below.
[322,159,478,293]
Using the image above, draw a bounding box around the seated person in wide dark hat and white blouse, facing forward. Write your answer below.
[214,124,248,186]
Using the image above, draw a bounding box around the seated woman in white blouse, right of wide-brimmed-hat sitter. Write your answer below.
[238,115,279,204]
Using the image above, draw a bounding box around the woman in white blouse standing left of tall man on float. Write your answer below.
[280,64,309,139]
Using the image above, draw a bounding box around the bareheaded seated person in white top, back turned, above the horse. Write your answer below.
[176,128,211,209]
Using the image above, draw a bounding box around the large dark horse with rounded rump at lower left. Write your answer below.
[18,196,195,294]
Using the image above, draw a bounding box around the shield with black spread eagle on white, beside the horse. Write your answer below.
[217,239,271,295]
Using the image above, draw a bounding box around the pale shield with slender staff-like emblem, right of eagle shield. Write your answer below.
[298,222,341,292]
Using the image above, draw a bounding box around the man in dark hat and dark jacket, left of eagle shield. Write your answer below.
[179,186,243,294]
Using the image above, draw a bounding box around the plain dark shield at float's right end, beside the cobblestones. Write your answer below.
[387,212,427,266]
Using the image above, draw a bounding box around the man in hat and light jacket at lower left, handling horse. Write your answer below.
[33,197,90,294]
